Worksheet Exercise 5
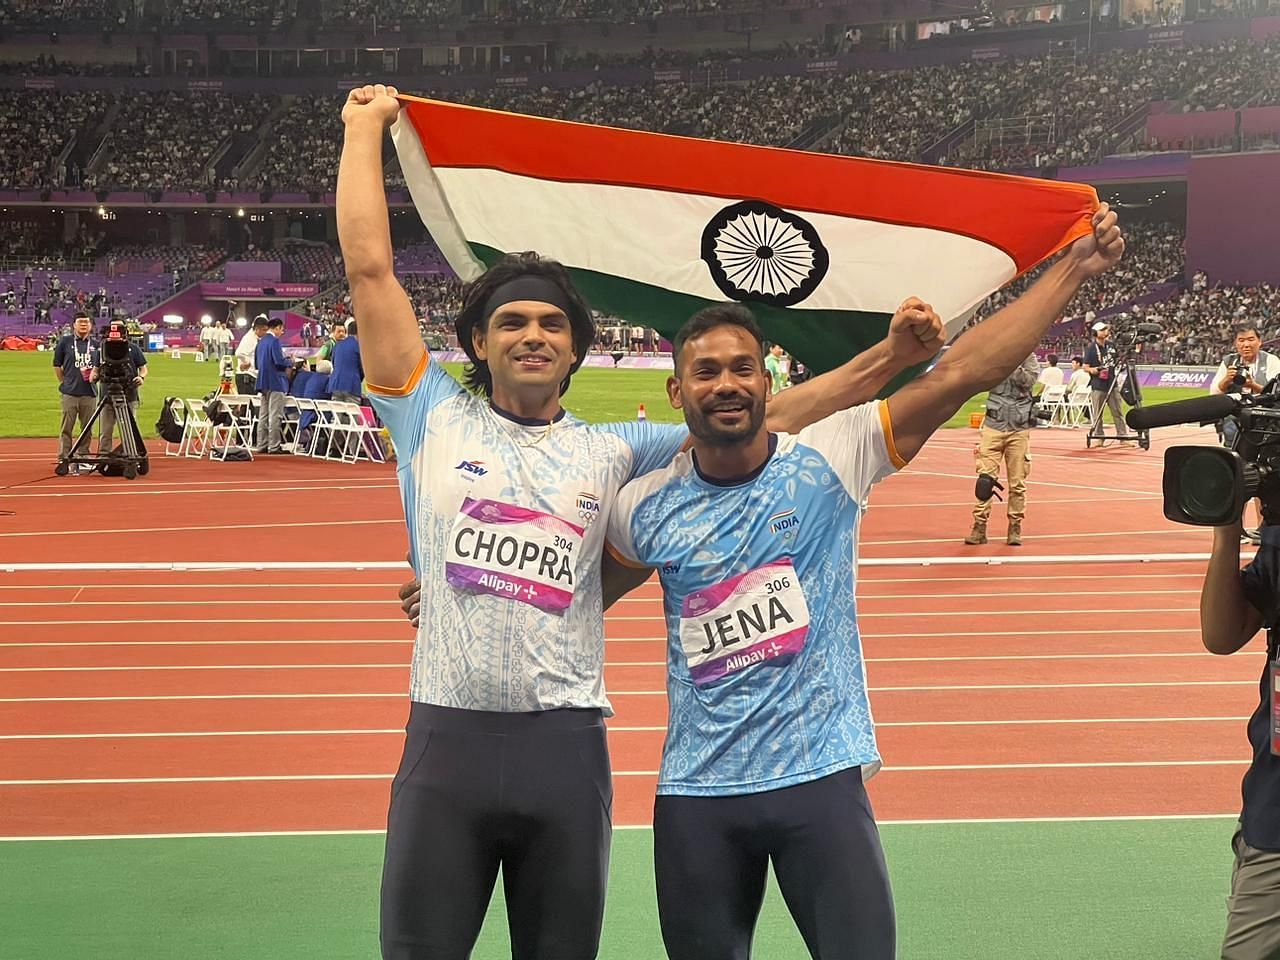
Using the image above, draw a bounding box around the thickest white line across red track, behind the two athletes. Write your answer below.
[0,555,1210,573]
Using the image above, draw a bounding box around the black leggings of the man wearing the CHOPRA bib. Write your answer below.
[381,703,613,960]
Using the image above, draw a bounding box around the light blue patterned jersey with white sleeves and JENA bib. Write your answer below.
[609,403,904,796]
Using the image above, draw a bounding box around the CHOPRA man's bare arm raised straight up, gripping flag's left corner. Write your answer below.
[338,83,425,390]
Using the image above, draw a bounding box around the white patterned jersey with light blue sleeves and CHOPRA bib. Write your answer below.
[370,356,687,712]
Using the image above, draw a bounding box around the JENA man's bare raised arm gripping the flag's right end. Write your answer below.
[888,204,1124,460]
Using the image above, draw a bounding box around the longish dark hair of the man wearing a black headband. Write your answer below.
[453,251,595,398]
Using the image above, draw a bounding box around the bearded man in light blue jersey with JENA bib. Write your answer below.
[608,205,1124,960]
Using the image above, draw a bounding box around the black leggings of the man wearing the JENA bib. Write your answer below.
[653,767,895,960]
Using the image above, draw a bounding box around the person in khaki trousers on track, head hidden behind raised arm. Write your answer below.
[964,353,1039,547]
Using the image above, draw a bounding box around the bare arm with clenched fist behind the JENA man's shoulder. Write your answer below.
[765,297,943,434]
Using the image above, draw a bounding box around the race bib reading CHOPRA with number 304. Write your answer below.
[444,497,582,613]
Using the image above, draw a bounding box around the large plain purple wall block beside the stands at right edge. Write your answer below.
[1187,152,1280,284]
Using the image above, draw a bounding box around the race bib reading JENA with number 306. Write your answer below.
[680,558,809,686]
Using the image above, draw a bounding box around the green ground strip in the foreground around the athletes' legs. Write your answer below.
[0,818,1233,960]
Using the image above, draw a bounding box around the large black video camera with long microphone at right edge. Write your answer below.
[1125,376,1280,526]
